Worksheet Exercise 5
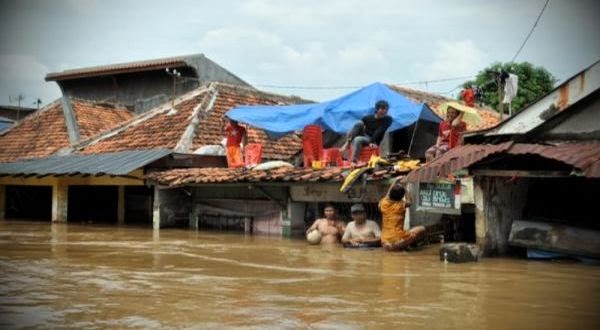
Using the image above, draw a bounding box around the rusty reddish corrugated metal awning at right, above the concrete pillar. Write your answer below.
[408,142,600,182]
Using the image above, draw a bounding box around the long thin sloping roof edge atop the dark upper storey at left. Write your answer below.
[46,54,204,81]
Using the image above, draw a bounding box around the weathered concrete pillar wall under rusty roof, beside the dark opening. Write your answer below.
[474,177,529,256]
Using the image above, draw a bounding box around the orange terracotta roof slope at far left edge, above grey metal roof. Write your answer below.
[0,101,69,163]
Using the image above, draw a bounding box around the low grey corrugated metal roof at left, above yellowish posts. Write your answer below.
[0,149,173,176]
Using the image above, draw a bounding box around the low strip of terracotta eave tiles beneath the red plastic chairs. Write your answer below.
[146,166,408,186]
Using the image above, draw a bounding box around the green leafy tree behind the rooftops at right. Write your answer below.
[463,62,556,114]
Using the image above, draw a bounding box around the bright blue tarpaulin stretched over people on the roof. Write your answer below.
[226,83,442,138]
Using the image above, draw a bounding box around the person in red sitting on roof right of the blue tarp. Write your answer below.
[425,106,467,162]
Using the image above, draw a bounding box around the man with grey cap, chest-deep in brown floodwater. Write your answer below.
[342,204,381,247]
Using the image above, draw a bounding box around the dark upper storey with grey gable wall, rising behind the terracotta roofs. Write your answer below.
[46,54,250,113]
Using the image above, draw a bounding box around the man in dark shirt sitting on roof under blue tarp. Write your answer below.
[340,100,392,163]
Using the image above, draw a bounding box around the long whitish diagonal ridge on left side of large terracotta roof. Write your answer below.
[72,84,210,150]
